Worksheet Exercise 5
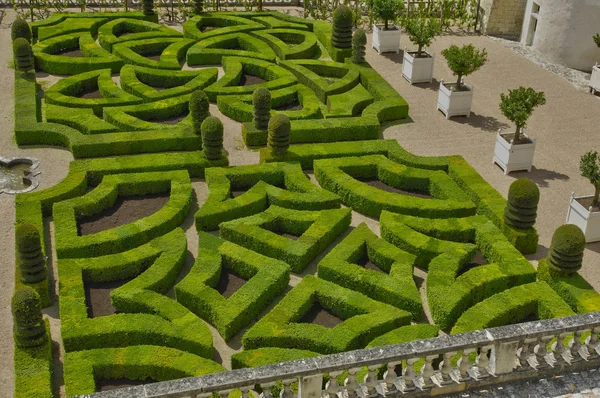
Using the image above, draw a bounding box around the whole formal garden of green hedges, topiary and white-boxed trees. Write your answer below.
[3,0,600,397]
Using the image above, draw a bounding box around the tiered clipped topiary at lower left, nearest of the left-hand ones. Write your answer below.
[11,287,48,348]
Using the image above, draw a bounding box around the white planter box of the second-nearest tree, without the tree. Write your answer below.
[494,130,535,175]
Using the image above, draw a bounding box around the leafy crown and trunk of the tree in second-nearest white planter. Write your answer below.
[500,86,546,144]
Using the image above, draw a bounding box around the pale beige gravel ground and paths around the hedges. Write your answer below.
[0,7,600,398]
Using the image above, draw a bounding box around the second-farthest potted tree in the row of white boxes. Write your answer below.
[402,17,442,84]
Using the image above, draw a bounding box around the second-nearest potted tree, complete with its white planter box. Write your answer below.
[494,87,546,174]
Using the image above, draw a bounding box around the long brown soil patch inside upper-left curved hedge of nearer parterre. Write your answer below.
[78,192,169,236]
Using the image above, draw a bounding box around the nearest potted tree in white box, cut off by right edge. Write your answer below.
[567,151,600,242]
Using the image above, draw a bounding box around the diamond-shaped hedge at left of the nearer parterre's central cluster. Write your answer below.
[175,232,290,340]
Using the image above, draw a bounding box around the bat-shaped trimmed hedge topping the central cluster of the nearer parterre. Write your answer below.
[195,163,340,231]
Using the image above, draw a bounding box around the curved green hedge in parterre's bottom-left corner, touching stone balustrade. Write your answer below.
[64,345,225,396]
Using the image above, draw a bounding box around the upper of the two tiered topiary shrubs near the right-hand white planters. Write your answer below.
[504,178,540,229]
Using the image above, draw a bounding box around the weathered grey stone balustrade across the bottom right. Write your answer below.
[79,312,600,398]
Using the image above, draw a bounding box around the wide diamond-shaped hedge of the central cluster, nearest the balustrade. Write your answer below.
[242,275,411,354]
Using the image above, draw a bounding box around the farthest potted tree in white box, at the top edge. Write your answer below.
[372,0,404,54]
